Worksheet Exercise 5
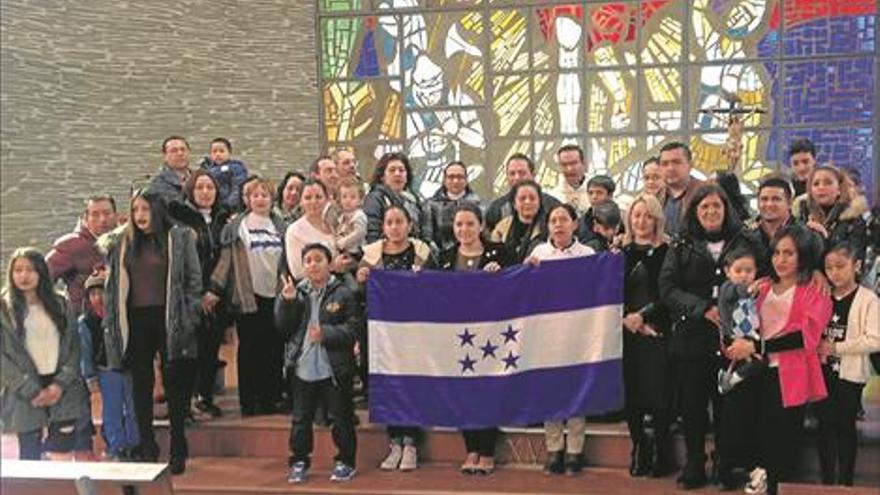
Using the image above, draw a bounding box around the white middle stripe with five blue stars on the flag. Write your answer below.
[369,305,623,377]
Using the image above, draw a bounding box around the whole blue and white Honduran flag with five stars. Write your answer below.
[367,254,623,428]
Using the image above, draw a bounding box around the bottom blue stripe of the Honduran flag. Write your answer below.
[370,359,623,428]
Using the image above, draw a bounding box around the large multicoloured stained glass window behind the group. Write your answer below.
[317,0,880,203]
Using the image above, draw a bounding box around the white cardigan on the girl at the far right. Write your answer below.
[834,286,880,383]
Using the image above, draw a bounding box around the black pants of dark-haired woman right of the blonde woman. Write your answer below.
[675,356,722,465]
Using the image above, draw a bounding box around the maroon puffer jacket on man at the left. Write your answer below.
[46,223,104,315]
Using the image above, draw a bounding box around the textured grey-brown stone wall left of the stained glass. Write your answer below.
[0,0,319,268]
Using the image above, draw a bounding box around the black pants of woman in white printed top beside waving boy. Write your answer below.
[236,296,284,414]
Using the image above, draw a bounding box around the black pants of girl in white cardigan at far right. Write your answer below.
[816,367,865,486]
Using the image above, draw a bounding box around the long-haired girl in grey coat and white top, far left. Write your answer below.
[0,248,86,460]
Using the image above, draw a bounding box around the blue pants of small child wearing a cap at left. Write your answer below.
[98,370,140,455]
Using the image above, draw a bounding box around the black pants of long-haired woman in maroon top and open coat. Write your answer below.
[126,306,196,460]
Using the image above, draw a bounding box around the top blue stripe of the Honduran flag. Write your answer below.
[367,253,623,323]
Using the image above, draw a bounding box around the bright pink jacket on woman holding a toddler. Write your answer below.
[757,284,831,407]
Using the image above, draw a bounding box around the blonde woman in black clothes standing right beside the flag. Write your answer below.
[623,193,672,476]
